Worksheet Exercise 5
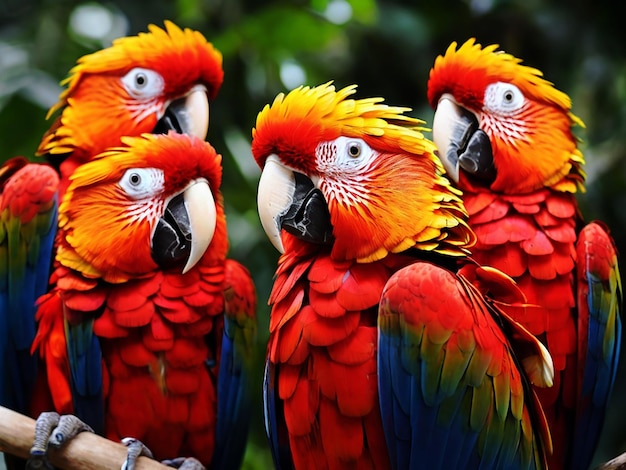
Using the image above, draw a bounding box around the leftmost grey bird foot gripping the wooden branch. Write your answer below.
[26,411,94,470]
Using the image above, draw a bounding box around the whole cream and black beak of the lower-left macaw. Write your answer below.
[152,179,217,274]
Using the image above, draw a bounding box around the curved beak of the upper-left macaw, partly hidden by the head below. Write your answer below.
[153,85,209,140]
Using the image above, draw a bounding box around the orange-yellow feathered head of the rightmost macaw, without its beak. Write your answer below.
[428,39,584,193]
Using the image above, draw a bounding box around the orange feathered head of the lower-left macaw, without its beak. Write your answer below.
[57,133,227,283]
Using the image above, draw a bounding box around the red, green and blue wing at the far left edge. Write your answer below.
[0,159,58,413]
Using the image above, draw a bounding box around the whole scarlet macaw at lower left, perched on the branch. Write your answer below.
[2,132,256,469]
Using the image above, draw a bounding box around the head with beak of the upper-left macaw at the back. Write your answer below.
[38,21,224,165]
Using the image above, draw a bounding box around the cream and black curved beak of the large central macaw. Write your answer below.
[257,155,333,253]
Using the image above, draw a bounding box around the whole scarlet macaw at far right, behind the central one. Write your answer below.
[428,39,622,469]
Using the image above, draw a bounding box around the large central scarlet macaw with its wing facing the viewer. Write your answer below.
[252,84,551,469]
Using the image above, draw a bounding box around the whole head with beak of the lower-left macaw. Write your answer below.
[57,132,227,283]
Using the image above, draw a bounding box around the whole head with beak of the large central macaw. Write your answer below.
[252,83,474,262]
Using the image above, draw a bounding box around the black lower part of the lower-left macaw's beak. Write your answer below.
[152,194,191,269]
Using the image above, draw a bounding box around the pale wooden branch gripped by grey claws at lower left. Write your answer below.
[0,406,171,470]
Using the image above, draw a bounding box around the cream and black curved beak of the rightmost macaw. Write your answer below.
[433,94,496,183]
